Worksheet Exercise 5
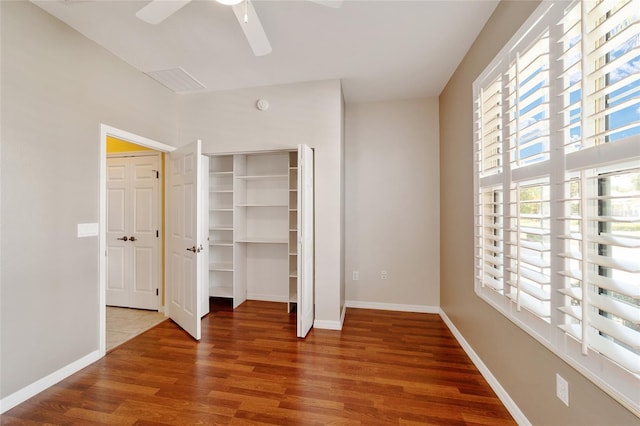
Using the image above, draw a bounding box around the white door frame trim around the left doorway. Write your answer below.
[98,123,176,357]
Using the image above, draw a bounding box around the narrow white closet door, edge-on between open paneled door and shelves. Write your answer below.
[198,155,209,316]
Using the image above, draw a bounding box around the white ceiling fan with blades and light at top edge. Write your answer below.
[136,0,343,56]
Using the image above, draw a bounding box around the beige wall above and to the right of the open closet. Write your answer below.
[179,80,344,328]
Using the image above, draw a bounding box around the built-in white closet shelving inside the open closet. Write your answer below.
[209,148,313,322]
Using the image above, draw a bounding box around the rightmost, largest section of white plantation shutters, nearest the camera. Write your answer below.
[559,0,640,374]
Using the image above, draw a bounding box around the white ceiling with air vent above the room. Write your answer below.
[32,0,498,102]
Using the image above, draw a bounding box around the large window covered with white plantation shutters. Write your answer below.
[473,0,640,416]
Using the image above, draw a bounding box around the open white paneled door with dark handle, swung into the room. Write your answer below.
[167,141,201,340]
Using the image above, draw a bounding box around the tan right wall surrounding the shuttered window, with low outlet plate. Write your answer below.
[440,1,640,426]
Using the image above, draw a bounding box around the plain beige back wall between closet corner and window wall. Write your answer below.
[345,98,440,310]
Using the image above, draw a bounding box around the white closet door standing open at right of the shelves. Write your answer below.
[297,145,315,337]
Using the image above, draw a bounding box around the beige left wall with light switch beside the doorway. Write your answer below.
[0,1,177,398]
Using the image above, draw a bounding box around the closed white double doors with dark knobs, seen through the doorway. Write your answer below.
[106,154,160,310]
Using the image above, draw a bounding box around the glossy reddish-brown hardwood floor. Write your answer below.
[1,299,515,425]
